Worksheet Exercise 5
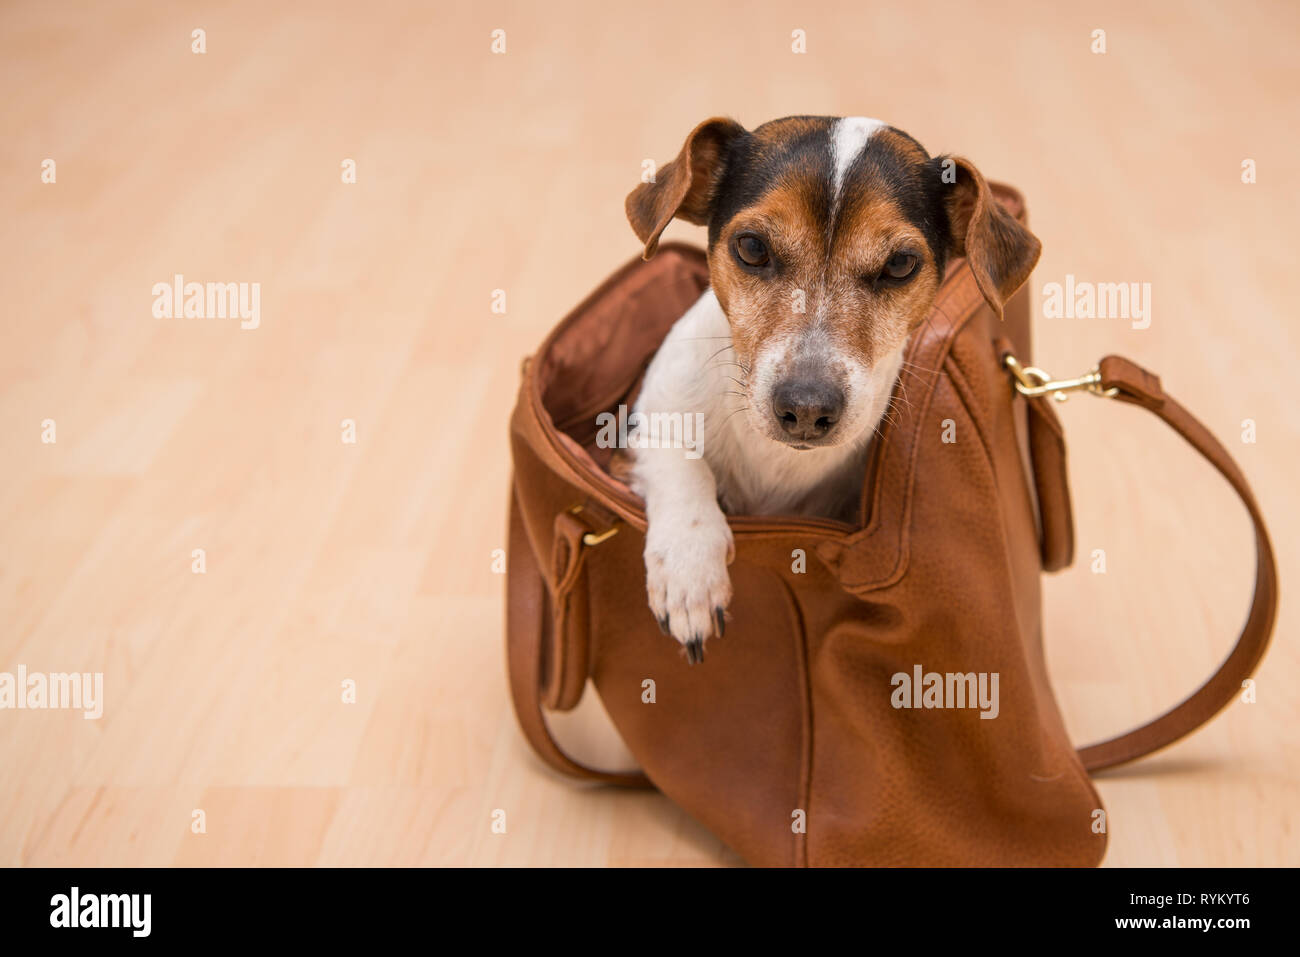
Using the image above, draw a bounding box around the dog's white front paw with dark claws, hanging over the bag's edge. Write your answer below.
[646,506,736,664]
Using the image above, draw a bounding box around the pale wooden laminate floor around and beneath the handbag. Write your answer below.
[0,0,1300,865]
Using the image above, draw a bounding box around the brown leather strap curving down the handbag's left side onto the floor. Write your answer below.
[506,480,654,788]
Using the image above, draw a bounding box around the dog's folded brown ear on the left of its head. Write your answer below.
[624,117,745,259]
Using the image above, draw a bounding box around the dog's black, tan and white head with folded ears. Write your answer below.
[627,117,1039,449]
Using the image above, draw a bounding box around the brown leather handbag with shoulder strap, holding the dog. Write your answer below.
[506,186,1277,866]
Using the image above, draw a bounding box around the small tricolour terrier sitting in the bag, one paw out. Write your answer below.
[624,116,1040,664]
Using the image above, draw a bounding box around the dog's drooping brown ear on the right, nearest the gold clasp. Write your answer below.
[935,156,1043,319]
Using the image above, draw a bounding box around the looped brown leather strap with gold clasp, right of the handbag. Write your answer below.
[1002,352,1278,771]
